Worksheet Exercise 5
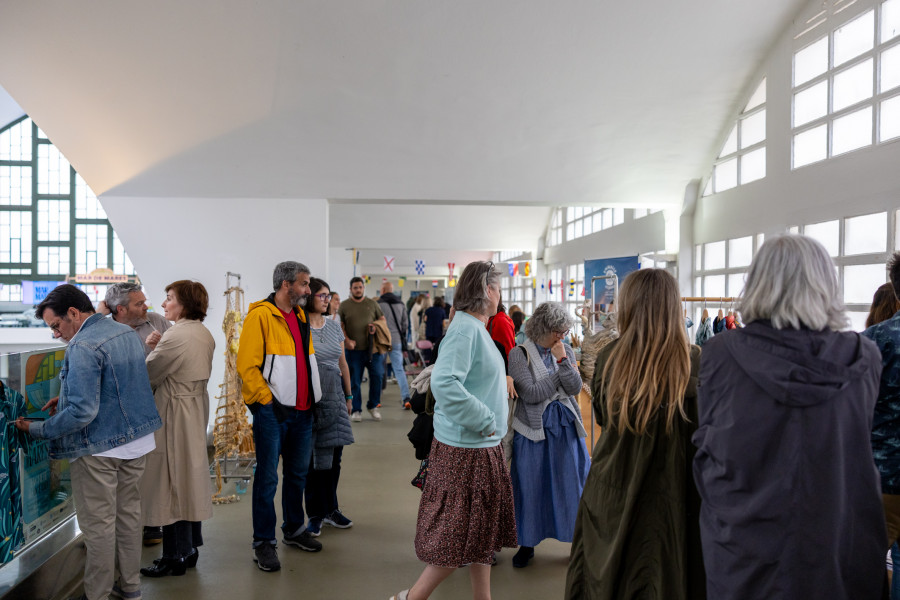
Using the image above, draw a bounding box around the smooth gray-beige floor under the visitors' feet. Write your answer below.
[135,384,569,600]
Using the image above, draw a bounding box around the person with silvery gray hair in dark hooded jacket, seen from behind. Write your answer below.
[693,235,887,600]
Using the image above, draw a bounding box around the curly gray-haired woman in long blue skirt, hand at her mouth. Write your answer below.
[509,302,590,568]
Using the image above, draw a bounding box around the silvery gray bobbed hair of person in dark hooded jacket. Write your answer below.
[738,234,850,331]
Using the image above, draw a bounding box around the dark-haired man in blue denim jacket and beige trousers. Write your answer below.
[16,285,162,600]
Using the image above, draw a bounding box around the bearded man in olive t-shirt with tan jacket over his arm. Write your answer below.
[338,277,384,421]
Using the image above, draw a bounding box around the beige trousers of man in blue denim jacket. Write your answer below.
[70,456,145,600]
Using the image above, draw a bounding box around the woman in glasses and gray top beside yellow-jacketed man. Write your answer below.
[304,277,353,537]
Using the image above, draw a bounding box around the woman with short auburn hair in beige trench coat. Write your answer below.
[141,280,216,577]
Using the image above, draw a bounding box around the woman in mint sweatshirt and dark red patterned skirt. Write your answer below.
[393,261,517,600]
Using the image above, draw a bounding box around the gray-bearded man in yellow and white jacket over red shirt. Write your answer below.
[237,261,322,571]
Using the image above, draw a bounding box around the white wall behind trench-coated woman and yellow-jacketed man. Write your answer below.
[100,197,329,436]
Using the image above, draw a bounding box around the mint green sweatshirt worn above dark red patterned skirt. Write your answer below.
[431,312,509,448]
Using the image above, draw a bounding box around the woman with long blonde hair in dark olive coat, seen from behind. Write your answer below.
[566,269,705,600]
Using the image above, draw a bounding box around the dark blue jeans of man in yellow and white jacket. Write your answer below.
[253,400,313,546]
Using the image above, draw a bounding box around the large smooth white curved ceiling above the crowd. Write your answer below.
[0,0,805,253]
